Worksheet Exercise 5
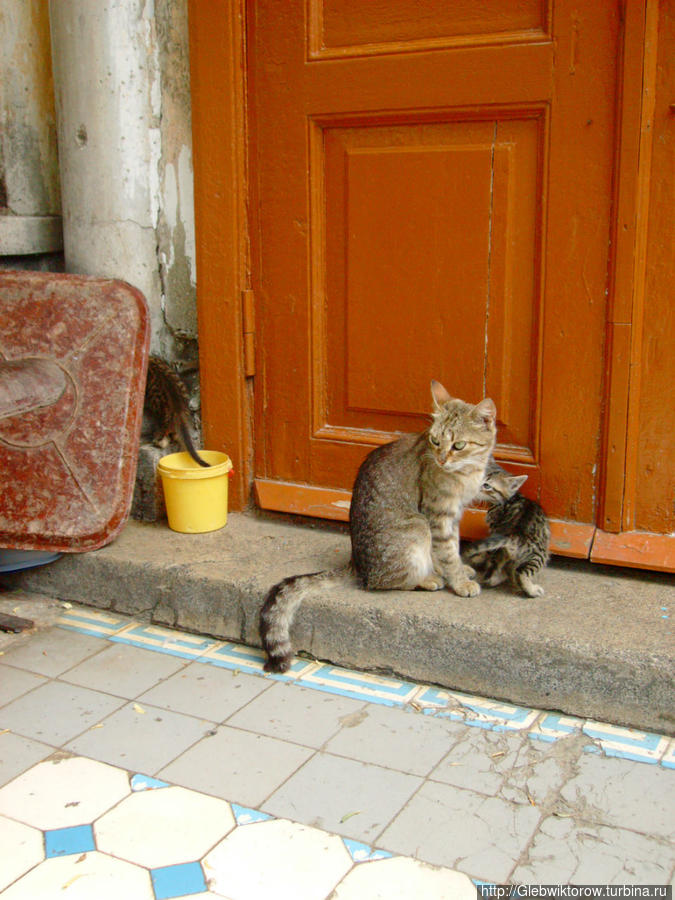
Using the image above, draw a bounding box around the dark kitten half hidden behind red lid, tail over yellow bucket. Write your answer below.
[143,356,209,466]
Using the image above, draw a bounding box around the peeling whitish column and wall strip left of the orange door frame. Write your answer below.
[50,0,197,362]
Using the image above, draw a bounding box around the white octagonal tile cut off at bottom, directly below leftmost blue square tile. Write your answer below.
[2,853,155,900]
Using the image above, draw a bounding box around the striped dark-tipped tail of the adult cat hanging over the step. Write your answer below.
[260,562,353,672]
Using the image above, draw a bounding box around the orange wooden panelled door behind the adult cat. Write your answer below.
[248,0,618,541]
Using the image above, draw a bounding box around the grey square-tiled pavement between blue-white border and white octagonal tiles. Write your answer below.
[0,589,675,884]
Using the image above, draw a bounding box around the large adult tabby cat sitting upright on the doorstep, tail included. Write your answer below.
[260,381,497,672]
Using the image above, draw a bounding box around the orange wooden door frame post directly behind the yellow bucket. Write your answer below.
[188,0,253,510]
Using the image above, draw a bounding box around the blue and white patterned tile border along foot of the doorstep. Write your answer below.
[57,608,675,768]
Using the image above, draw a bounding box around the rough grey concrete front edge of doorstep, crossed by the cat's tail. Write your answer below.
[3,528,675,733]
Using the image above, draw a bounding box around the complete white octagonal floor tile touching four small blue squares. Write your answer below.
[94,787,236,869]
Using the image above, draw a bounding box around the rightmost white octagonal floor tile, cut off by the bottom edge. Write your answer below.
[332,856,476,900]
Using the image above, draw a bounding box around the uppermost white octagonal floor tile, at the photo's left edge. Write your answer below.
[0,757,131,830]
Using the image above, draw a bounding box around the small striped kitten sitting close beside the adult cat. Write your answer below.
[464,460,551,597]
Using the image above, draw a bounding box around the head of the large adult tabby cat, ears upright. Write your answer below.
[428,381,497,472]
